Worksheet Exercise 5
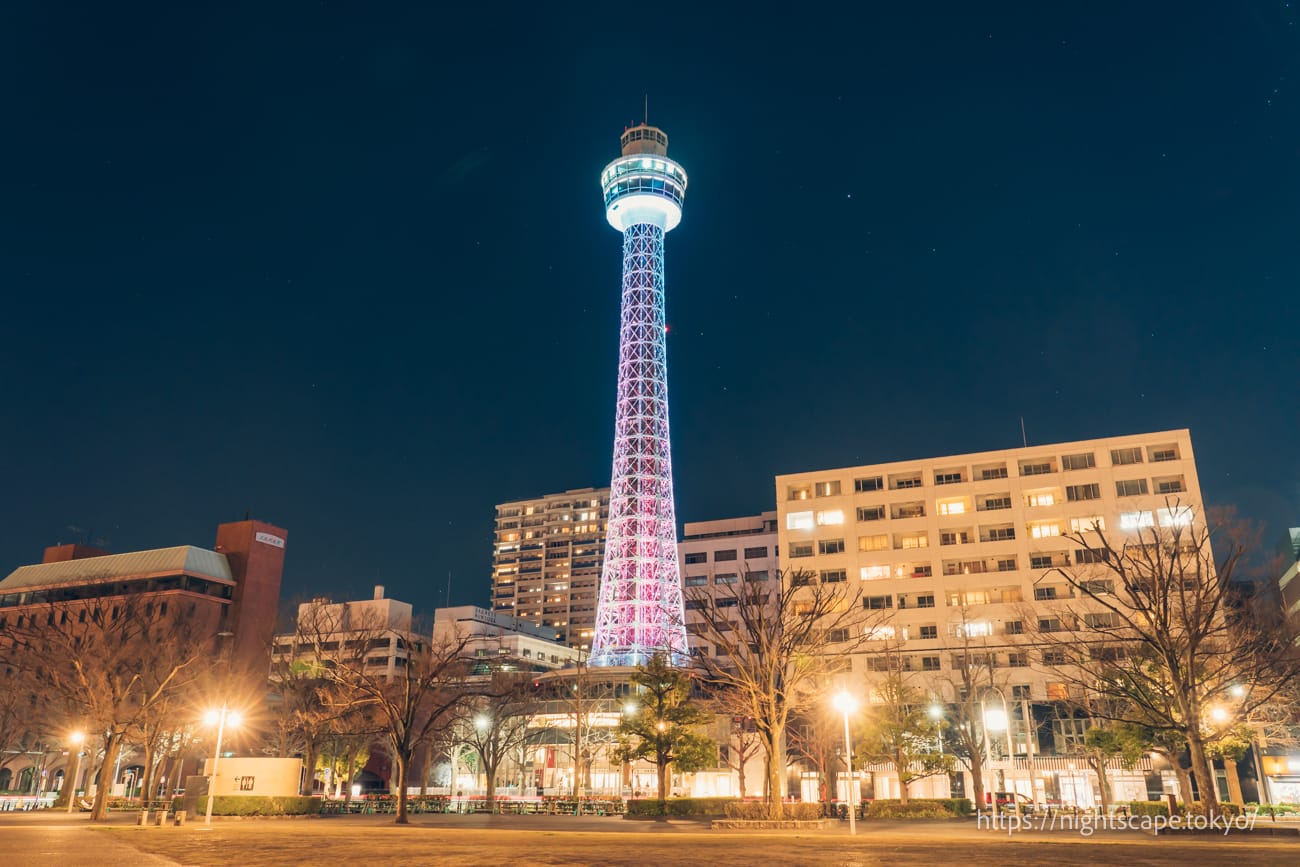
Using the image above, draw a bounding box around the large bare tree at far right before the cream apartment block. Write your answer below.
[1039,499,1300,815]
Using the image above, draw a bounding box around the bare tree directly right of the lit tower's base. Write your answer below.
[688,568,884,819]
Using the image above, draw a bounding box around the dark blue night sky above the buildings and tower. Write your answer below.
[0,1,1300,611]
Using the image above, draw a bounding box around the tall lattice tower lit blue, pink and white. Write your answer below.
[592,123,688,666]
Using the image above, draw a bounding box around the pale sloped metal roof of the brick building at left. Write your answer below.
[0,545,234,593]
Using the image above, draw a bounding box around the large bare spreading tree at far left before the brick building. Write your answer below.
[0,595,213,822]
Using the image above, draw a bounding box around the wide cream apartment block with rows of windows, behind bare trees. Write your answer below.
[776,430,1204,806]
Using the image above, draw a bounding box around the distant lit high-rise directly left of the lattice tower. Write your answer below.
[491,487,610,647]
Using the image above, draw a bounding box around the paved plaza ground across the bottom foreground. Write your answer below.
[0,812,1300,867]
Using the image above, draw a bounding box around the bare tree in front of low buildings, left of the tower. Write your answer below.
[299,603,469,824]
